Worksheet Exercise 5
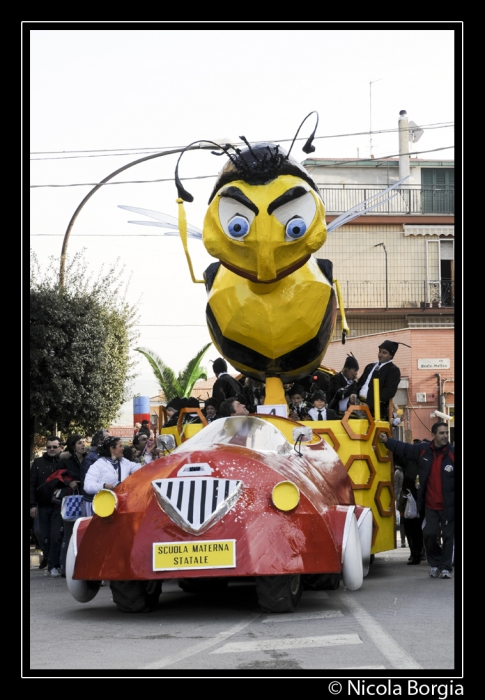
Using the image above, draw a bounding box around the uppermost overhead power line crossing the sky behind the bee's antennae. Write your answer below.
[30,122,454,160]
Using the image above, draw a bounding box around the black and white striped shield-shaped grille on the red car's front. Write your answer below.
[152,476,243,535]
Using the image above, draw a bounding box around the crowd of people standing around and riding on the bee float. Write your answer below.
[30,340,454,578]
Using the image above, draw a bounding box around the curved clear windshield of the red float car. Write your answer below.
[174,416,292,454]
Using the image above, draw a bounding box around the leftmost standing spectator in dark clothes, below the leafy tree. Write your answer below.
[30,435,63,578]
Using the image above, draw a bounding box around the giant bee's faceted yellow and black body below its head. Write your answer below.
[202,258,337,383]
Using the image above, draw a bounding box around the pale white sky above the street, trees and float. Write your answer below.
[28,22,461,423]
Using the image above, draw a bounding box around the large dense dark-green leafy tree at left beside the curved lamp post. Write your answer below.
[30,251,136,435]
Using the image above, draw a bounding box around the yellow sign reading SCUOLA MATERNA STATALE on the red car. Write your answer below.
[153,540,236,571]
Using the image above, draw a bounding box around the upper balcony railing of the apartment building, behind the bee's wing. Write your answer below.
[320,185,455,215]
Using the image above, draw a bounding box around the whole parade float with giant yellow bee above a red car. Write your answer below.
[66,113,395,612]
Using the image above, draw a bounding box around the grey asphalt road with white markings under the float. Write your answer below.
[26,548,459,678]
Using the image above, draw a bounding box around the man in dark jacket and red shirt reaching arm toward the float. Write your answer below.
[379,422,455,579]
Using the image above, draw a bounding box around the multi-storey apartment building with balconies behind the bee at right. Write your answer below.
[303,111,455,439]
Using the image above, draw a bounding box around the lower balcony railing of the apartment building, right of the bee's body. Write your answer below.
[339,280,455,309]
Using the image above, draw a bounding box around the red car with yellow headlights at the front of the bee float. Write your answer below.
[66,415,372,612]
